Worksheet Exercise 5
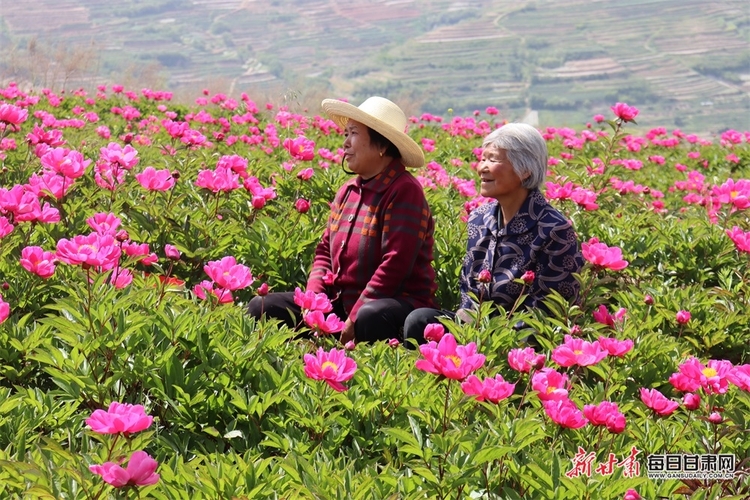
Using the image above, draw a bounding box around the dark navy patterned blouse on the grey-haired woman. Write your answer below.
[460,189,583,310]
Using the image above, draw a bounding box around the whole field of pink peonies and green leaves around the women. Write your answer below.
[0,83,750,500]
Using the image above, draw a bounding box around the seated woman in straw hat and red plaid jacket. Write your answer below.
[249,97,437,343]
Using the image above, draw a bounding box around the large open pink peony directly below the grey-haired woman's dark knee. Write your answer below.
[415,333,485,380]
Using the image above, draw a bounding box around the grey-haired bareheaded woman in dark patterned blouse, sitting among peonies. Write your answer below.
[404,123,583,343]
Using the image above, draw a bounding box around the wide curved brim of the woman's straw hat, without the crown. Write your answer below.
[321,99,424,168]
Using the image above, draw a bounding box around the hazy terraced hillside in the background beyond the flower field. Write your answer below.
[0,0,750,132]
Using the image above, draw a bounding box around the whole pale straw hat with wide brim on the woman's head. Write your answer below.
[321,96,424,167]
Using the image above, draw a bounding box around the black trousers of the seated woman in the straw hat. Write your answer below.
[247,292,414,342]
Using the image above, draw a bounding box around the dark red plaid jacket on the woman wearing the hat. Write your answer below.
[307,161,437,321]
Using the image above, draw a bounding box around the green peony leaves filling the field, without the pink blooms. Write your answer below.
[0,84,750,500]
